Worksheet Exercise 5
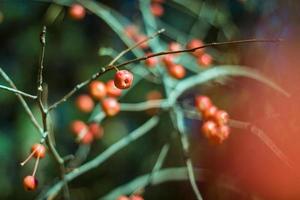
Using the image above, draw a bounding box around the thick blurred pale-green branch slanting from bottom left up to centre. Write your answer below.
[38,116,159,199]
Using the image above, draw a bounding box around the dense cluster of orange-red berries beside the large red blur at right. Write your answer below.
[195,96,230,144]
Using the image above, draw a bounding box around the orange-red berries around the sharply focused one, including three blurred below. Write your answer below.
[71,70,133,144]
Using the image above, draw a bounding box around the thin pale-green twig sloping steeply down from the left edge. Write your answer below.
[0,67,44,136]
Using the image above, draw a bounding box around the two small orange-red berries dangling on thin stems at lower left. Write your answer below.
[21,143,46,191]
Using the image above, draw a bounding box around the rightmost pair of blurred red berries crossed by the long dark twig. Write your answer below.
[187,39,213,67]
